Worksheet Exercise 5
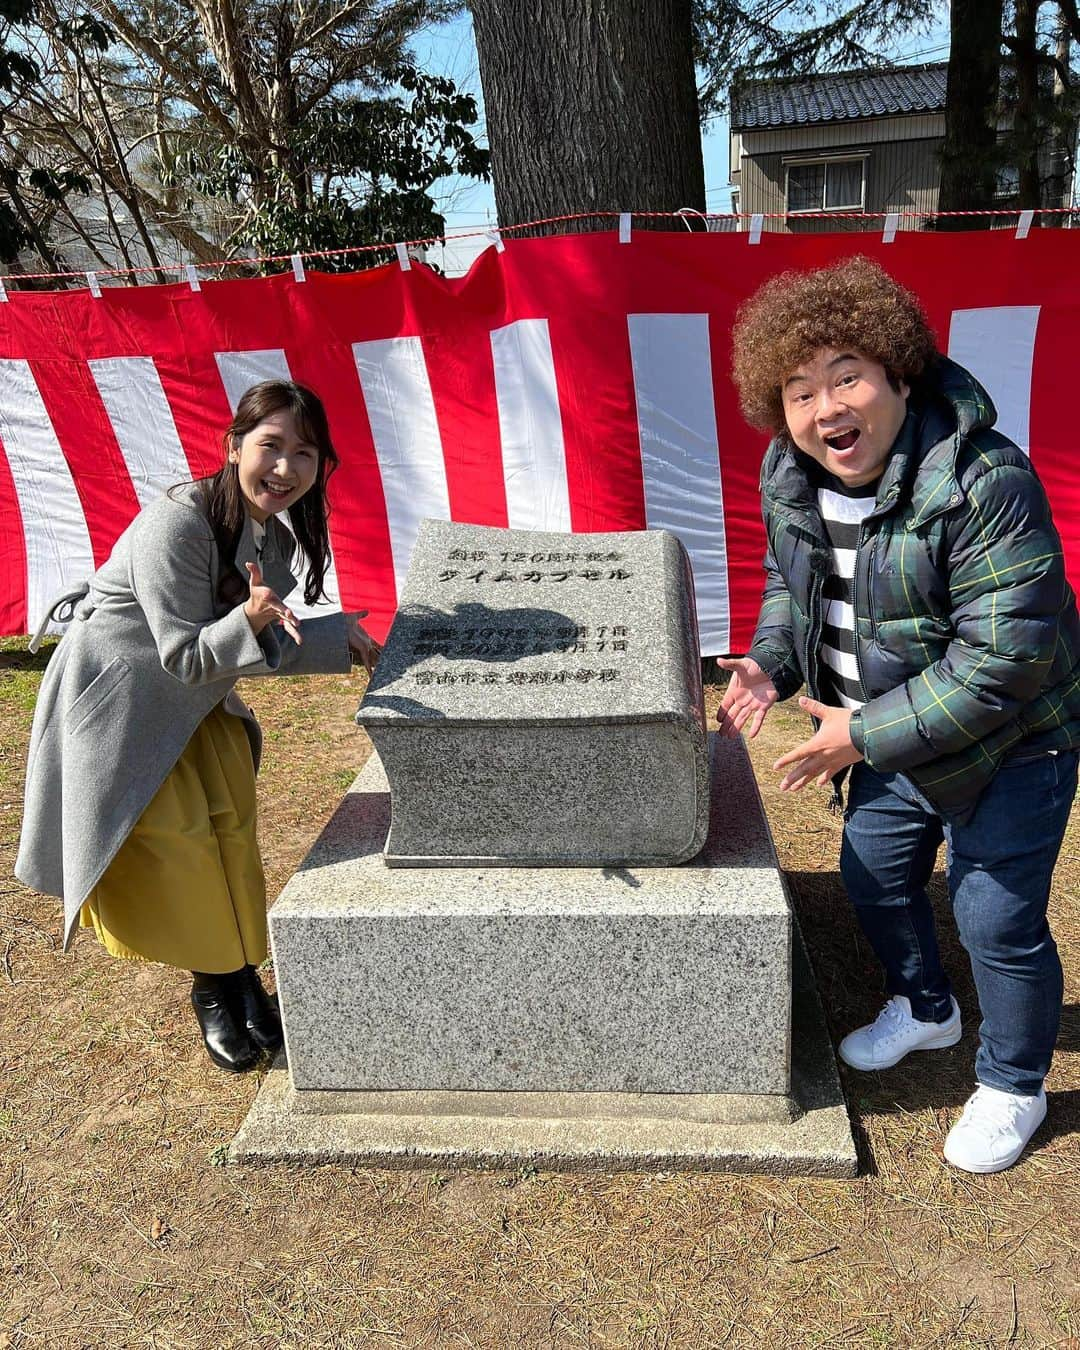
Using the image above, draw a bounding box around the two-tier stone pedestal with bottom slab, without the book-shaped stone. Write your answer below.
[232,737,856,1176]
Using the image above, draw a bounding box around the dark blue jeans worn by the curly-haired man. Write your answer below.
[840,751,1079,1095]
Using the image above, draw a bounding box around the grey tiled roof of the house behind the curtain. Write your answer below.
[732,63,948,131]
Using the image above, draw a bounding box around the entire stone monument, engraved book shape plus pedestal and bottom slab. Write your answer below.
[231,522,856,1176]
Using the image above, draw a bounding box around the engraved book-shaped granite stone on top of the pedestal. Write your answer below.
[356,520,709,867]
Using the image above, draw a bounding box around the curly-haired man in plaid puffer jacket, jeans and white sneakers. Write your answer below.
[720,258,1080,1172]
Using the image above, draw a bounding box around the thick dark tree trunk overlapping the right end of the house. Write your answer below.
[937,0,1002,230]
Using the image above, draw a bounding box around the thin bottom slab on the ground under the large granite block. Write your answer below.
[228,929,859,1177]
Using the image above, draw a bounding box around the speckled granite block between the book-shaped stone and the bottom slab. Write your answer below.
[270,736,791,1095]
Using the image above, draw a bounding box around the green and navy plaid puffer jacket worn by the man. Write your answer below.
[749,358,1080,822]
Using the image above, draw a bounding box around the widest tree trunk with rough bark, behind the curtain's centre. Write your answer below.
[471,0,705,225]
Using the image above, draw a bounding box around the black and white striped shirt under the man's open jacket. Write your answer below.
[818,477,878,707]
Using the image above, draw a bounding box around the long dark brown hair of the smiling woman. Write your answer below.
[203,379,338,605]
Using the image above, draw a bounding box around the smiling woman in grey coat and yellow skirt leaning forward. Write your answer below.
[15,381,378,1072]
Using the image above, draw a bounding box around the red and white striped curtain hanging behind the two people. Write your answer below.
[0,230,1080,655]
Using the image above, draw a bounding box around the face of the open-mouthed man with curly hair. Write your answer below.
[782,347,911,487]
